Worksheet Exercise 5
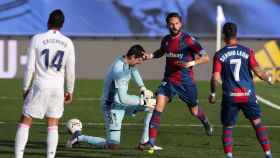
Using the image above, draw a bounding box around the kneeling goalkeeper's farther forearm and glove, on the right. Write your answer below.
[131,68,153,98]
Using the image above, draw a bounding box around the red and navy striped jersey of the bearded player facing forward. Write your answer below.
[160,32,206,85]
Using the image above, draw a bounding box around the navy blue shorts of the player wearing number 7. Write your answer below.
[221,101,261,126]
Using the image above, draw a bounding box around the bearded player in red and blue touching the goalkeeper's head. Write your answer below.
[145,13,213,152]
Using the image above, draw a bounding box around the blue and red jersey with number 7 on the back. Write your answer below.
[213,45,258,103]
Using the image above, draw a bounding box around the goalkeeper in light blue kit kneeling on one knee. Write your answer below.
[67,45,162,149]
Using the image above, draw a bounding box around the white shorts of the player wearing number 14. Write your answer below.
[23,86,64,119]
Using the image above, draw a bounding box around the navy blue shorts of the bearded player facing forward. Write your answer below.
[157,81,198,107]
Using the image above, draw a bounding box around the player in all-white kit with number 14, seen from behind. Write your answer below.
[15,10,75,158]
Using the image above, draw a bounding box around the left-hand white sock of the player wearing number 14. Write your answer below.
[15,123,30,158]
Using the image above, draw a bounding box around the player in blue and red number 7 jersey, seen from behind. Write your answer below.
[209,23,272,158]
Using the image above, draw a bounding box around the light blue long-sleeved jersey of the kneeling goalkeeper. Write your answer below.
[102,56,144,108]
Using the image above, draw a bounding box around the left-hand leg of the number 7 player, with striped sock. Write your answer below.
[221,102,239,158]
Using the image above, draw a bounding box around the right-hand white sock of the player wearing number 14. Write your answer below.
[47,126,58,158]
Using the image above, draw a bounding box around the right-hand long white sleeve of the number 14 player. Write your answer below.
[66,41,75,93]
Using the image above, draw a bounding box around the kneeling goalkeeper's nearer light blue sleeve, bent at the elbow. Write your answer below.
[113,67,140,105]
